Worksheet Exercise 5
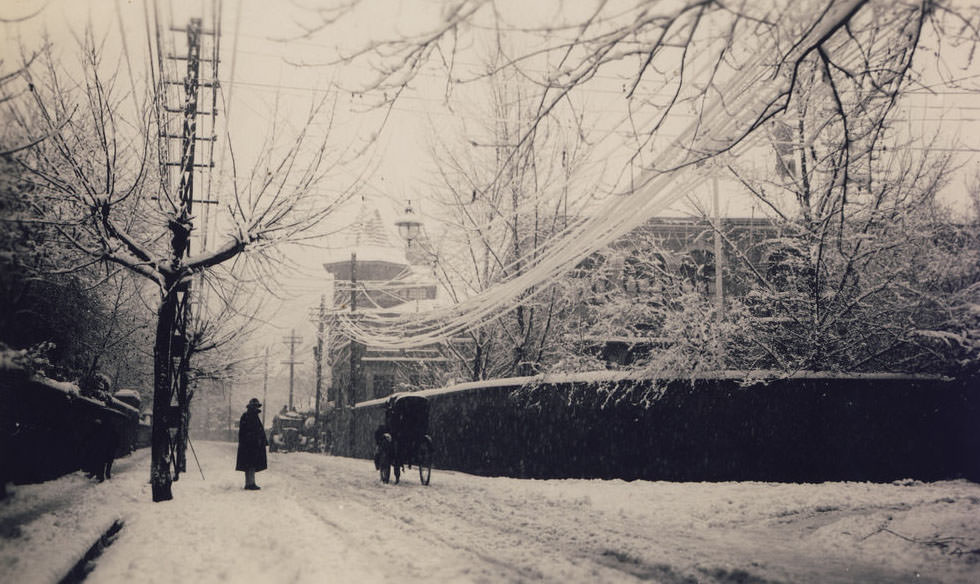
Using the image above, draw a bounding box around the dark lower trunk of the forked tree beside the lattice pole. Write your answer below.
[150,286,177,503]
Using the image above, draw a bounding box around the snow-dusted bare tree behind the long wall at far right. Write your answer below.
[712,43,975,373]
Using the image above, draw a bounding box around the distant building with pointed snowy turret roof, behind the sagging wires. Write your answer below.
[323,207,446,405]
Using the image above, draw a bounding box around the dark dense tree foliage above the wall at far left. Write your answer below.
[0,143,156,387]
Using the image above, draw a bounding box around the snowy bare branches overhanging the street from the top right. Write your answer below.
[302,0,978,360]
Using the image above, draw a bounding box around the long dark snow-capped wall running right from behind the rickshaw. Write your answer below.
[352,375,980,482]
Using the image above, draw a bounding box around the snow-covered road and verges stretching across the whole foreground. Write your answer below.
[0,443,980,584]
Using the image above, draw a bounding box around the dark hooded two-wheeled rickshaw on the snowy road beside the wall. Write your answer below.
[374,393,432,485]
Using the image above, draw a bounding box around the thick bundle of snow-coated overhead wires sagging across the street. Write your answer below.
[337,0,872,349]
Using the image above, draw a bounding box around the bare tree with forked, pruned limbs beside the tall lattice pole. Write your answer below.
[4,32,349,501]
